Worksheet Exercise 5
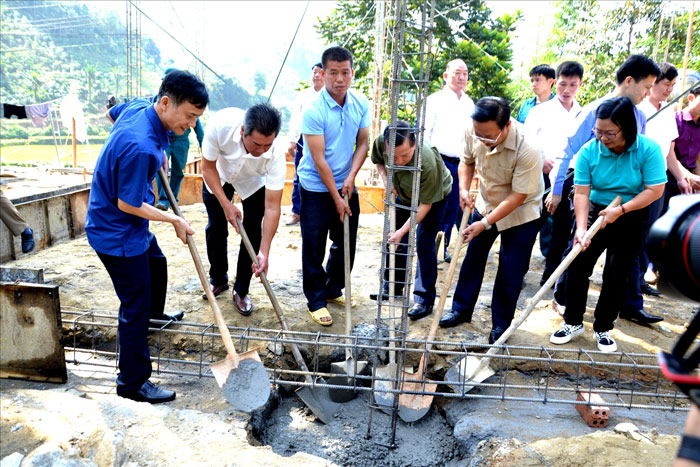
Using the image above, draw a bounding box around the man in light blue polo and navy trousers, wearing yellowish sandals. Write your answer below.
[297,47,370,326]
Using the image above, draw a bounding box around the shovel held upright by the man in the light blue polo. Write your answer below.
[328,194,367,402]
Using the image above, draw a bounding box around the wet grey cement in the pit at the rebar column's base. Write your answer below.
[257,393,463,467]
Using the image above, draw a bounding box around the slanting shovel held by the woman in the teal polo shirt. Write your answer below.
[445,196,622,395]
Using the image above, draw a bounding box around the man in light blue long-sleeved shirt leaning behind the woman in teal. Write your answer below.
[545,55,663,324]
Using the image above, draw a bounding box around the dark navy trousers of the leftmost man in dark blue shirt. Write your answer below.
[97,237,168,394]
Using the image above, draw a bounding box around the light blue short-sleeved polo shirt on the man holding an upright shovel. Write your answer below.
[297,88,370,192]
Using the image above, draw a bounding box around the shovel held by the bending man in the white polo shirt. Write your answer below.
[236,218,340,424]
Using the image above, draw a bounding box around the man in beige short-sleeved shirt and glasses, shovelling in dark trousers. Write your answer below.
[440,97,544,344]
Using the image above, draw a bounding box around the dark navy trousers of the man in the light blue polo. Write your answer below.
[299,186,360,311]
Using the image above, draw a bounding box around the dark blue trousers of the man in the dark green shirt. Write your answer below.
[384,198,446,306]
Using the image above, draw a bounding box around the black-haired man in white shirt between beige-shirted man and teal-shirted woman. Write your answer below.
[525,61,583,285]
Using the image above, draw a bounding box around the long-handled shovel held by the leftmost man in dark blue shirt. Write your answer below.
[159,167,270,412]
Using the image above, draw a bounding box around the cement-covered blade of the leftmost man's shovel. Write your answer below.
[209,350,270,412]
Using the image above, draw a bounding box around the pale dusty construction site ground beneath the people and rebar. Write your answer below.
[0,200,693,467]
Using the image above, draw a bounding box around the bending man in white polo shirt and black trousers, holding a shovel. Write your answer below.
[202,104,286,316]
